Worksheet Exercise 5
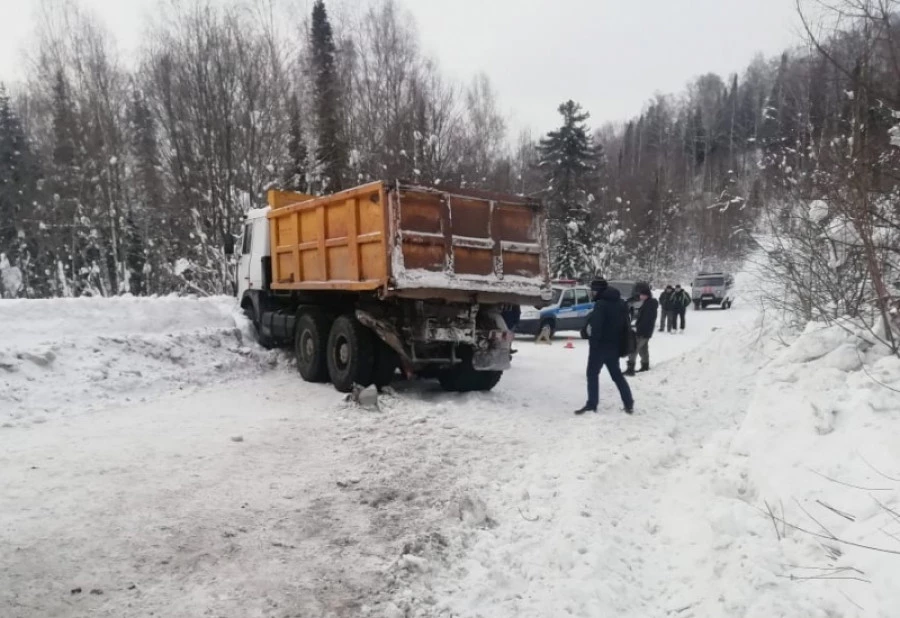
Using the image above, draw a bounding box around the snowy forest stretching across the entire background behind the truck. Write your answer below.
[0,0,900,352]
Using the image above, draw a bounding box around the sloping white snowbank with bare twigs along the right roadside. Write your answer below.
[662,325,900,618]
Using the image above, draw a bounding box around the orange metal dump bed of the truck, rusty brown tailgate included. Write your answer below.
[268,182,547,302]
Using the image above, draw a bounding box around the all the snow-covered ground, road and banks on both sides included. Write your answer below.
[0,290,900,618]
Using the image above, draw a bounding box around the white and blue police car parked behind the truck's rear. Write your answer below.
[516,281,594,338]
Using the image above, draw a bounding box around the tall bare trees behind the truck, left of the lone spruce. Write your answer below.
[0,0,513,297]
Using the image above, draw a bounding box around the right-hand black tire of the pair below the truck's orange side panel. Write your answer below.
[327,315,375,393]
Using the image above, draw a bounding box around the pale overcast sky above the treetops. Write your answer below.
[0,0,799,133]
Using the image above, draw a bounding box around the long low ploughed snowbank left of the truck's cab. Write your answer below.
[0,297,277,426]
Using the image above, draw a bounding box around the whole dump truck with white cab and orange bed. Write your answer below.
[237,182,551,392]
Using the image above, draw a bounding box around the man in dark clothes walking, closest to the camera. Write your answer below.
[575,279,634,415]
